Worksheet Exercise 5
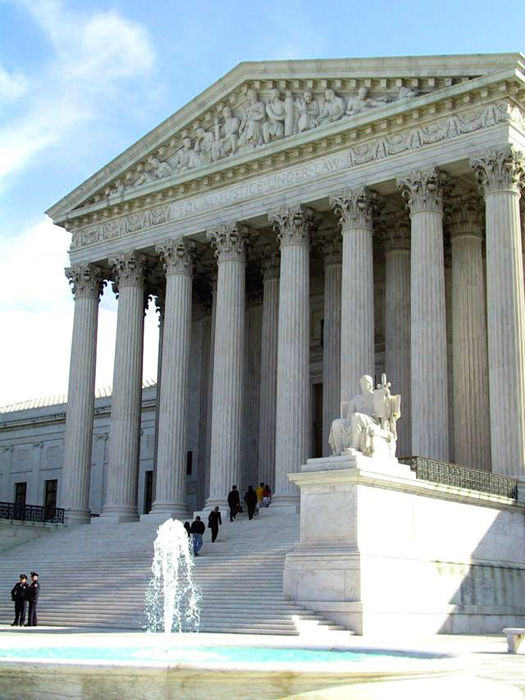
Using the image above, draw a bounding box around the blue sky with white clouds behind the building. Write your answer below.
[0,0,525,406]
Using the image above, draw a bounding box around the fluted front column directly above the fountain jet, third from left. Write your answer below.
[151,238,193,518]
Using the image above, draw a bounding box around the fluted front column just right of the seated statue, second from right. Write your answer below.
[398,168,448,460]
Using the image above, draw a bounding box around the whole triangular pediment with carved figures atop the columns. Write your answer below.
[48,54,524,223]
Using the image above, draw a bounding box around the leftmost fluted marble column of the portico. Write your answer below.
[61,264,103,525]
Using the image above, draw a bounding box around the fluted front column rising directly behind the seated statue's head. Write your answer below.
[330,187,377,401]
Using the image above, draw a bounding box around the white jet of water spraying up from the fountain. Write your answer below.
[146,518,199,634]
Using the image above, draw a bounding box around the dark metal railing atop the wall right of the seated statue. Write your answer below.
[399,457,518,500]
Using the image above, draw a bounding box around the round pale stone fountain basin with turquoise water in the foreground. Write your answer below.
[0,628,470,700]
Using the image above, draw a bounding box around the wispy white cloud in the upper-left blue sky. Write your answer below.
[0,0,155,189]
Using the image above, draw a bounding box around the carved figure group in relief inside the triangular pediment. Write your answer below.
[104,86,416,196]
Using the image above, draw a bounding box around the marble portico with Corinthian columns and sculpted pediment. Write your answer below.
[0,54,525,523]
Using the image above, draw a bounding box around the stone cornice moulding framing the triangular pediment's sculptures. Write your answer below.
[47,61,525,227]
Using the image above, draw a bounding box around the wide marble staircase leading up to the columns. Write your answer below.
[0,507,347,635]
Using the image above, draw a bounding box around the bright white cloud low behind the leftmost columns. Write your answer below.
[0,218,158,406]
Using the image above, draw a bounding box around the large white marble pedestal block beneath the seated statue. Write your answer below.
[284,452,525,634]
